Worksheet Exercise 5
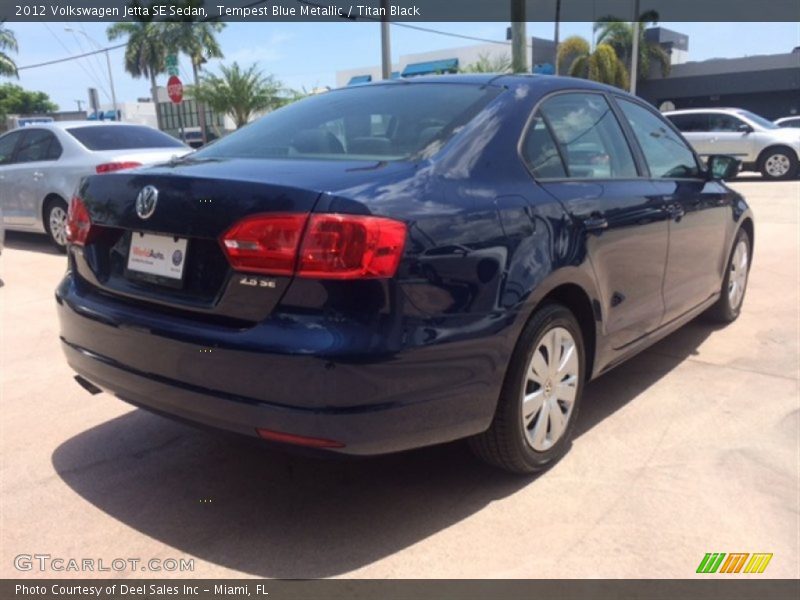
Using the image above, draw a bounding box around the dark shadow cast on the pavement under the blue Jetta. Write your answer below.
[52,322,713,578]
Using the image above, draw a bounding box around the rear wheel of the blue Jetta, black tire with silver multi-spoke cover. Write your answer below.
[470,304,586,474]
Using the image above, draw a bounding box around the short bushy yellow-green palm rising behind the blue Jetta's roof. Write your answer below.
[556,35,628,89]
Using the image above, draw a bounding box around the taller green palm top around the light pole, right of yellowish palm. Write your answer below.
[594,10,672,79]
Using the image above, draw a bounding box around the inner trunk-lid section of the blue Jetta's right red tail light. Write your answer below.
[222,214,308,275]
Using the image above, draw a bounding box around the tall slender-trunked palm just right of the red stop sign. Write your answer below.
[166,0,225,143]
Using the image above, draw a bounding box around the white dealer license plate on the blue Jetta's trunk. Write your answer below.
[125,231,189,288]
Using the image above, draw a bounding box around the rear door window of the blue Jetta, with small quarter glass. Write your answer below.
[524,93,638,179]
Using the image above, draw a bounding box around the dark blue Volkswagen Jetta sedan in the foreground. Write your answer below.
[56,75,754,473]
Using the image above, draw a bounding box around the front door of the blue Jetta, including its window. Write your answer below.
[616,96,731,323]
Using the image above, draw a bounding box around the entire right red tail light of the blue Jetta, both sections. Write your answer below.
[221,214,406,279]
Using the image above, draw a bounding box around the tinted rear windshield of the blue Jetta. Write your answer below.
[193,83,499,161]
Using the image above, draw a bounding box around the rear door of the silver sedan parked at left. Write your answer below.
[6,128,61,227]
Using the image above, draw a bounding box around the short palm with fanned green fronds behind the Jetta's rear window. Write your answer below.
[189,63,286,129]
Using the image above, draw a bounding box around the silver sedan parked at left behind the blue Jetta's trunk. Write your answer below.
[0,121,191,250]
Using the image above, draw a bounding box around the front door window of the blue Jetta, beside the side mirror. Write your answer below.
[617,98,700,178]
